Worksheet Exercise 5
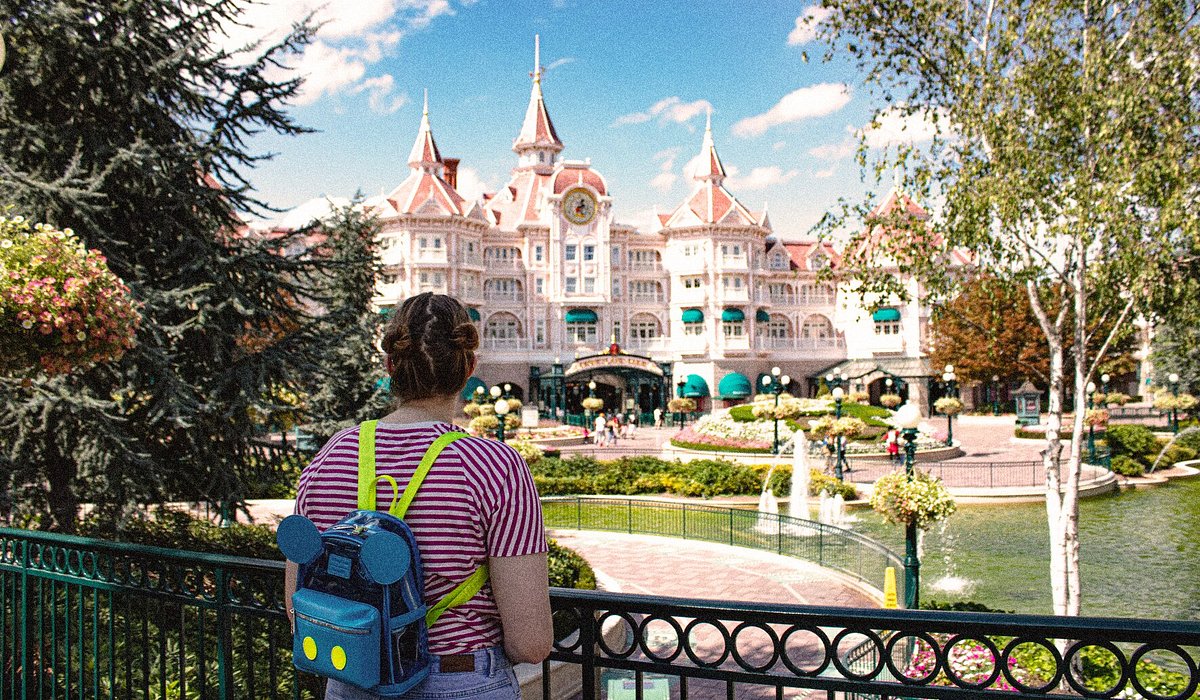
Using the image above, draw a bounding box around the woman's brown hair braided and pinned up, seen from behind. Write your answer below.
[379,292,479,403]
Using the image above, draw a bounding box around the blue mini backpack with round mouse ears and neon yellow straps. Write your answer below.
[276,420,487,698]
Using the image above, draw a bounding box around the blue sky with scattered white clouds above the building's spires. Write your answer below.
[226,0,928,239]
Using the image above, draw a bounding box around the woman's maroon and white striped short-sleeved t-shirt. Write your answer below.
[296,421,548,654]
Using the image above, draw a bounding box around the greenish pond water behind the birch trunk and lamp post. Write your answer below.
[851,477,1200,620]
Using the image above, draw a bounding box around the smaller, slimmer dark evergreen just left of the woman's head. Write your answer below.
[306,197,389,444]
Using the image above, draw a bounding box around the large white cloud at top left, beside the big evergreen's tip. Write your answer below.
[216,0,458,114]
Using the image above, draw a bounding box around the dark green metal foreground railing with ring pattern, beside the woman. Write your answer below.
[0,530,1200,700]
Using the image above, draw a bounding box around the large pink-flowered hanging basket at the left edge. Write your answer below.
[0,216,142,375]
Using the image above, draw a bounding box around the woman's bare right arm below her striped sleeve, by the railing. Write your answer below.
[487,552,554,664]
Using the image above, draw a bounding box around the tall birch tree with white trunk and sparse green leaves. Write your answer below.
[809,0,1200,615]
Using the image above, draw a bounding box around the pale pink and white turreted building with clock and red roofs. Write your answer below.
[374,49,945,405]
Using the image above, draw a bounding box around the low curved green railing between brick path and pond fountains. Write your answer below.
[541,496,905,600]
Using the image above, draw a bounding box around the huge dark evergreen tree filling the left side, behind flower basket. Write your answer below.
[0,0,333,531]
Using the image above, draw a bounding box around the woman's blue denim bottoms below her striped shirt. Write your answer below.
[325,646,521,700]
